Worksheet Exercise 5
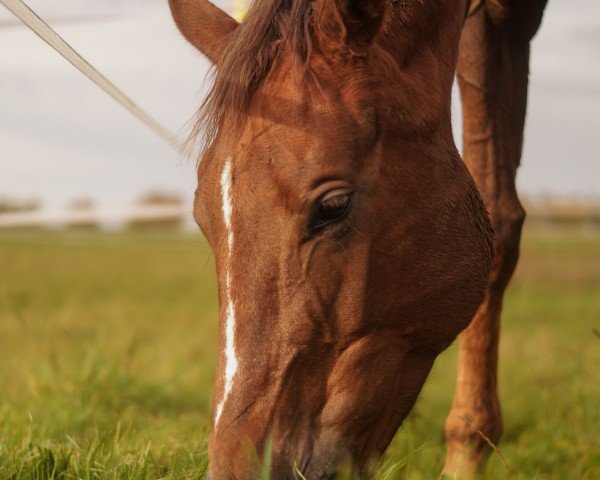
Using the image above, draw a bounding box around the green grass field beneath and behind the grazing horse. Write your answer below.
[0,231,600,480]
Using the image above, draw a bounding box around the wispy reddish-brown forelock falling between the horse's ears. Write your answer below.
[192,0,313,147]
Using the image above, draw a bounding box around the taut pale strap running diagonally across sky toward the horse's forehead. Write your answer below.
[0,0,179,150]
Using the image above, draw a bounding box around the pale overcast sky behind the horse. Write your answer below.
[0,0,600,208]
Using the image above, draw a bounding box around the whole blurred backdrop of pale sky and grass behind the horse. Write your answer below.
[0,0,600,480]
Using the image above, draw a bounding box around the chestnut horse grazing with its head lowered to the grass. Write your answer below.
[170,0,545,480]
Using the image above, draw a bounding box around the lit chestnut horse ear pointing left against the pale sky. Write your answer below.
[169,0,238,63]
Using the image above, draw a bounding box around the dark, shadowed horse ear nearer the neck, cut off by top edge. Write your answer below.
[314,0,388,53]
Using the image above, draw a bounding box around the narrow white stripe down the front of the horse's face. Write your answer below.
[215,158,238,429]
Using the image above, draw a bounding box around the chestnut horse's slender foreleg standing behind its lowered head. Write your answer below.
[444,0,546,478]
